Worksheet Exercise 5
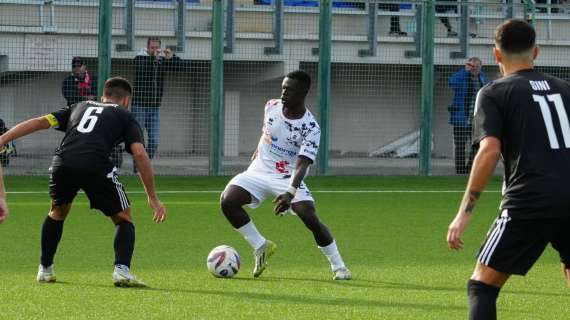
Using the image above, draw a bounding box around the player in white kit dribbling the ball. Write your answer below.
[220,70,352,280]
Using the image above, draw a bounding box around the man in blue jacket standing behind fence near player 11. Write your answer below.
[449,57,488,174]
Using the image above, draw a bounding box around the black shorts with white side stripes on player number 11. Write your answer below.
[477,210,570,275]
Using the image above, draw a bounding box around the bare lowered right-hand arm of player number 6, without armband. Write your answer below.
[131,142,166,223]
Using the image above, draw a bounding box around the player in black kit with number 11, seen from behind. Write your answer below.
[447,20,570,320]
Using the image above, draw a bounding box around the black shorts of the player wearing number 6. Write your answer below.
[49,166,130,216]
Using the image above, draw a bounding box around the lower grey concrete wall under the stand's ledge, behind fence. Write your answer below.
[0,63,478,156]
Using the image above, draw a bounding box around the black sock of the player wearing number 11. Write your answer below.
[467,280,501,320]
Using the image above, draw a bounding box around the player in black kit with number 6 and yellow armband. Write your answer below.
[0,77,166,287]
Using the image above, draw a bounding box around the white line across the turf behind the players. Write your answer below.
[6,190,501,194]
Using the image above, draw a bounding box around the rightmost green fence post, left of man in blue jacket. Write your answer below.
[420,0,435,176]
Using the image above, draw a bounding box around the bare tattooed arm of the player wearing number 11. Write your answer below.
[447,137,501,250]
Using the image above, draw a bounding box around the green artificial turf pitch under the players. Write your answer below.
[0,177,570,320]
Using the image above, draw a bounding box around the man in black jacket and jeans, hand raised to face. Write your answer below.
[132,37,180,159]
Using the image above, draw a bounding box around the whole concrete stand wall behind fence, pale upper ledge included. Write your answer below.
[0,2,570,162]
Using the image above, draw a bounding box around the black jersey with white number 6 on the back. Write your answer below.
[46,101,144,170]
